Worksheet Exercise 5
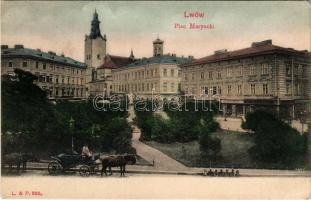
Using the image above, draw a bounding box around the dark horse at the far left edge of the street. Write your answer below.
[2,153,38,172]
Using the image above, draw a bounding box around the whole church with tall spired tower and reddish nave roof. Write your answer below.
[84,10,134,96]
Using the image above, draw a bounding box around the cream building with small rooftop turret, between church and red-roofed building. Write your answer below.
[112,38,191,99]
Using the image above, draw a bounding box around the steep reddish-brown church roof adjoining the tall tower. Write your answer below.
[98,55,135,69]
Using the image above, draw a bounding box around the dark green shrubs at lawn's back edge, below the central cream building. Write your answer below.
[135,101,219,143]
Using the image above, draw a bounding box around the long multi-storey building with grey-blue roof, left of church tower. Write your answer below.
[1,45,86,98]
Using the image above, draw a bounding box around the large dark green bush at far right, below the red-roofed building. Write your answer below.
[242,111,307,165]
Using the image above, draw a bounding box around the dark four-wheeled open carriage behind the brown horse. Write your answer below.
[48,153,100,176]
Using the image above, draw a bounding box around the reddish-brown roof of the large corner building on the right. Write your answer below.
[181,40,307,66]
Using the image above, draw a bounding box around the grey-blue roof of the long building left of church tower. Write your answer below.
[1,47,86,68]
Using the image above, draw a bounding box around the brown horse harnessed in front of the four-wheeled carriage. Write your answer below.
[101,154,136,176]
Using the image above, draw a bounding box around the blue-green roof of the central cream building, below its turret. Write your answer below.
[124,55,192,67]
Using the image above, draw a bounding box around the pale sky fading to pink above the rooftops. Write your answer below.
[1,1,311,61]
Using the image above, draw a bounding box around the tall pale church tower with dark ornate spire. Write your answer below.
[84,10,107,82]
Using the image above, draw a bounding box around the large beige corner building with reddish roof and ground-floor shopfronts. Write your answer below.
[180,40,311,118]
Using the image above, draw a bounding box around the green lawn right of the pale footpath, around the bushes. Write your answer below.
[145,131,303,169]
